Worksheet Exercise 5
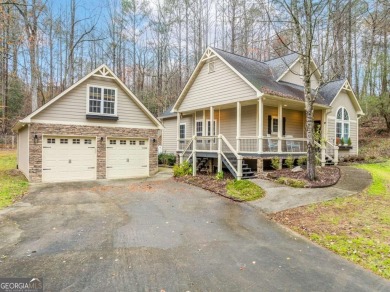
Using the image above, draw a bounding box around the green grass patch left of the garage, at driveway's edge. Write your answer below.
[0,151,28,209]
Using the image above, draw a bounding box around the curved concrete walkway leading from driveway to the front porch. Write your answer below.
[248,166,372,213]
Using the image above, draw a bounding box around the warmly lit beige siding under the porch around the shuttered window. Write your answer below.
[263,106,304,138]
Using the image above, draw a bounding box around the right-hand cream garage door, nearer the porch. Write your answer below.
[106,138,149,178]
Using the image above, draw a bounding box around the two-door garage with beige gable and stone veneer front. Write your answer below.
[13,65,163,182]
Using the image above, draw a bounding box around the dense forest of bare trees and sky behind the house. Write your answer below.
[0,0,390,133]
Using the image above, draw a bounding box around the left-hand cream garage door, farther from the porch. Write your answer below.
[42,136,96,182]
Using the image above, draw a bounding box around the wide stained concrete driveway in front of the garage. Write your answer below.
[0,179,390,291]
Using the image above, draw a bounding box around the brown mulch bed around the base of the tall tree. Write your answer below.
[263,166,341,188]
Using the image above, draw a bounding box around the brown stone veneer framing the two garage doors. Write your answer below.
[28,124,158,182]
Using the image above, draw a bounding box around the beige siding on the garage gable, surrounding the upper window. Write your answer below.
[32,77,156,127]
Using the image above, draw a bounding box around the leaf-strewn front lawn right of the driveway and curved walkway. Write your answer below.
[270,161,390,279]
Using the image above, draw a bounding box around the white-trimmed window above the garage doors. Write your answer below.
[88,86,116,115]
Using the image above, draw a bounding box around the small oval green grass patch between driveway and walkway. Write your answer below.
[226,180,265,201]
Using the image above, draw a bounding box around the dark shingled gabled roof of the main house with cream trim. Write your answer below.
[174,47,363,113]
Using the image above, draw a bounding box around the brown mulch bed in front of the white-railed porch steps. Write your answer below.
[175,174,242,202]
